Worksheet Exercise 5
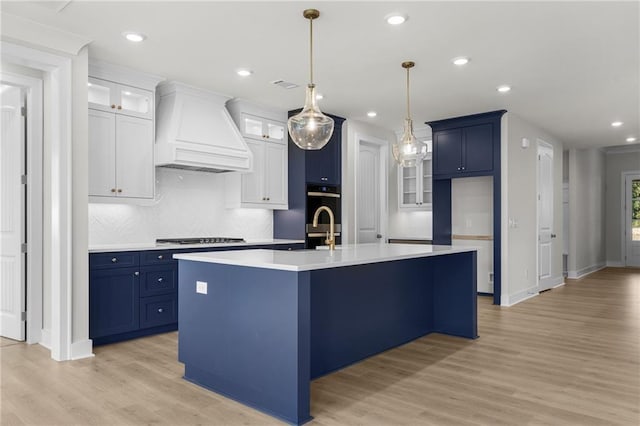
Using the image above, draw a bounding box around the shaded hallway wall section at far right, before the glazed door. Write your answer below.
[567,149,606,278]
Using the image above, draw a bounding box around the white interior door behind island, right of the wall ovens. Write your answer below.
[356,143,382,243]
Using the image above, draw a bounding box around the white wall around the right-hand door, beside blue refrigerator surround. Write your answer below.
[501,113,563,305]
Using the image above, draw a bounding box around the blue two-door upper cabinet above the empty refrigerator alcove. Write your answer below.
[433,123,494,177]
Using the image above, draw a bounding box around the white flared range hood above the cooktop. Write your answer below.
[155,81,253,173]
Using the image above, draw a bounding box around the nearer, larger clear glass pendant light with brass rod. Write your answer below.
[287,9,333,150]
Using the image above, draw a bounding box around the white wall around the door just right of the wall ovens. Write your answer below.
[342,119,397,244]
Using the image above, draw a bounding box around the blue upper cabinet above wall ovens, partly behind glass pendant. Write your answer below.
[298,121,342,185]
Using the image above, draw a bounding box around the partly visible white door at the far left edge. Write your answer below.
[0,85,26,340]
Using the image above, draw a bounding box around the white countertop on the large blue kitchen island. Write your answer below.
[173,243,476,271]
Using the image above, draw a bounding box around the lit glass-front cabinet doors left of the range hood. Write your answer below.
[87,77,153,119]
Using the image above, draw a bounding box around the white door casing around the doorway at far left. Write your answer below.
[1,41,74,361]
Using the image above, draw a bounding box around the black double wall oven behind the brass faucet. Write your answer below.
[305,184,342,248]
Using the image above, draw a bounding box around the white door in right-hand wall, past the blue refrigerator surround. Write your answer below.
[538,142,555,291]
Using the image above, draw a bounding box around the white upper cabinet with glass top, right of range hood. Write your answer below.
[226,99,289,210]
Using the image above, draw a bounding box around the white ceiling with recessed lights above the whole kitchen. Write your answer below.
[1,1,640,147]
